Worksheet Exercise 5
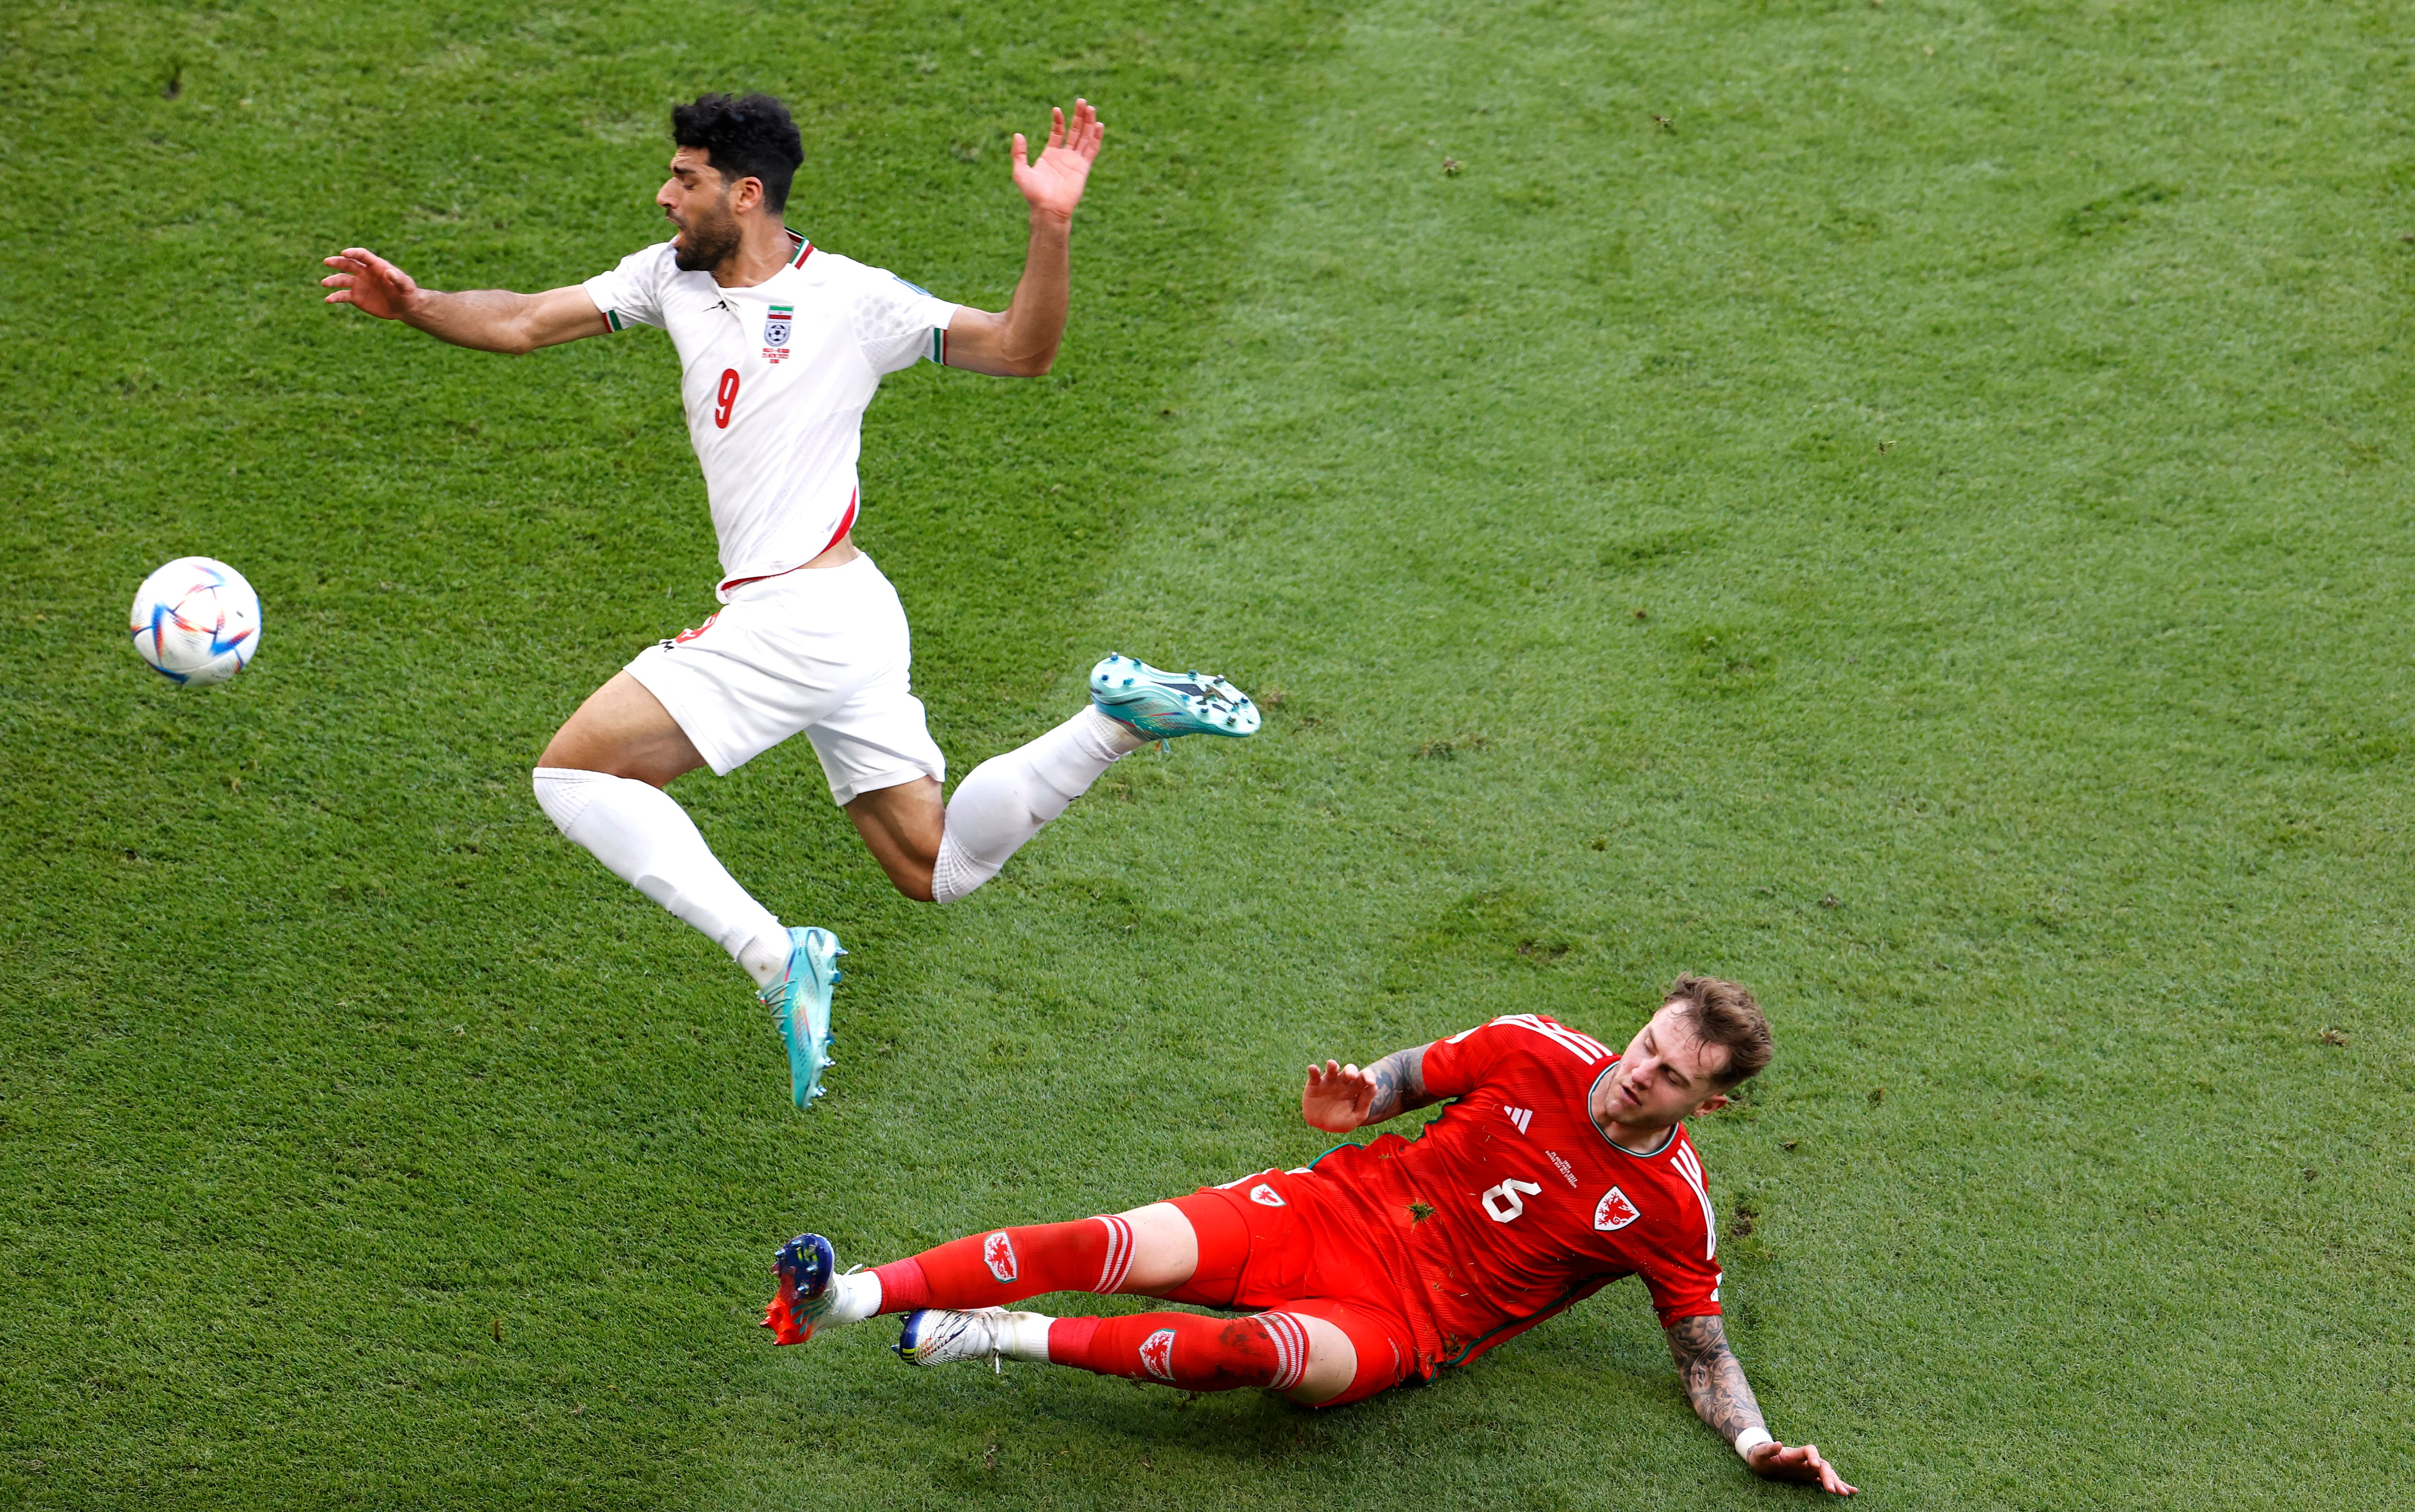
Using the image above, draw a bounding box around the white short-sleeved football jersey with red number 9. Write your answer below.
[582,232,956,601]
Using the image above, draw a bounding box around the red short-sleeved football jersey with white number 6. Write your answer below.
[1316,1015,1719,1365]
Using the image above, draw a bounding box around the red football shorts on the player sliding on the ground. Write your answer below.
[1166,1172,1422,1408]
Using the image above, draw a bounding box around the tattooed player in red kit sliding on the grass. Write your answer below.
[766,976,1855,1495]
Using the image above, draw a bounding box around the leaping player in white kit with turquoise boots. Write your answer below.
[321,94,1258,1106]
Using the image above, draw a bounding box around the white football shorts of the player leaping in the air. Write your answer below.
[628,555,947,805]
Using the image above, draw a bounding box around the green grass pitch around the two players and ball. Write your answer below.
[0,0,2415,1510]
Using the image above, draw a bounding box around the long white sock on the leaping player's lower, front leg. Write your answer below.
[536,766,787,986]
